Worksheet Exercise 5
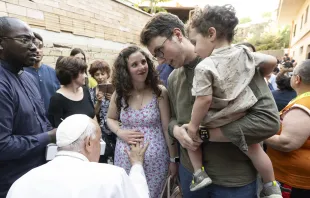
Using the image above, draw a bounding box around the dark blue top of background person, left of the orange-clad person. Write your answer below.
[272,90,296,111]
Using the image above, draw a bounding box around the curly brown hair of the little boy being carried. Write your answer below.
[189,5,239,42]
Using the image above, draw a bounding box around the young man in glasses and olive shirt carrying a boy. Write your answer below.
[140,13,279,198]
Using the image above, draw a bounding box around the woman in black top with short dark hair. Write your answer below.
[48,57,95,128]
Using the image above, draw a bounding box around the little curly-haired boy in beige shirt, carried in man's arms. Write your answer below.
[188,5,282,198]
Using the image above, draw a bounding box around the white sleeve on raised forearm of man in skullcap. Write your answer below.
[122,164,150,198]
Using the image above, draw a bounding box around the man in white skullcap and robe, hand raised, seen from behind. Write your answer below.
[7,114,149,198]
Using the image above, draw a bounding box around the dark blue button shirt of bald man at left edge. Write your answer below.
[0,60,52,198]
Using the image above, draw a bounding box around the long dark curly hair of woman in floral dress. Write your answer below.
[112,46,161,112]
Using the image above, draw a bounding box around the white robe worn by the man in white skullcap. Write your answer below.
[7,151,149,198]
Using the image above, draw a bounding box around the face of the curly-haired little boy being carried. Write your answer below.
[188,28,215,58]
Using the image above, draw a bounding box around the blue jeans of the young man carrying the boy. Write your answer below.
[179,164,257,198]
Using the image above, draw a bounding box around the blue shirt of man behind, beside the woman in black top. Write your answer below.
[24,64,60,112]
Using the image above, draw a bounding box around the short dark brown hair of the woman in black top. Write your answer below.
[55,56,87,85]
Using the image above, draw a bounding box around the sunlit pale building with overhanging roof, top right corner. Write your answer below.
[278,0,310,63]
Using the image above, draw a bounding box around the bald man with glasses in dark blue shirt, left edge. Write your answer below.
[0,17,56,198]
